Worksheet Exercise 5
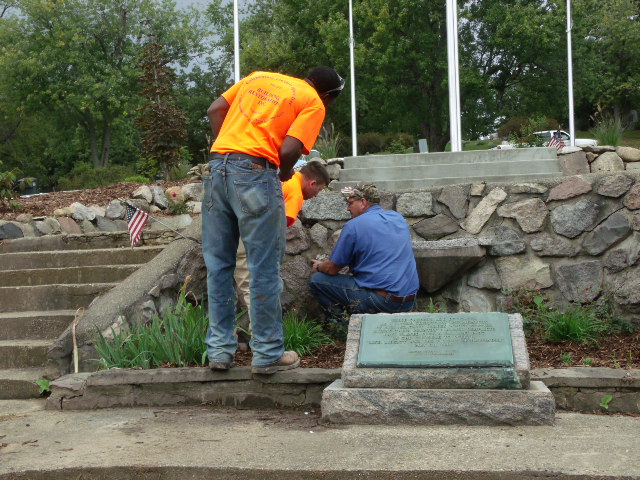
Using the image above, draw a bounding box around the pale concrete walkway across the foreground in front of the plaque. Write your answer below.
[0,400,640,480]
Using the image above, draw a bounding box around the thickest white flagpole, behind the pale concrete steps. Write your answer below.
[447,0,462,152]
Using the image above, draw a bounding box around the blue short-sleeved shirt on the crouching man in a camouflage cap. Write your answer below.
[330,205,420,296]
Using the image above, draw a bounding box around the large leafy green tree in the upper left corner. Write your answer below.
[0,0,202,167]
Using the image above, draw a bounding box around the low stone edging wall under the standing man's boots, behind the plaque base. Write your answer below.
[47,367,640,413]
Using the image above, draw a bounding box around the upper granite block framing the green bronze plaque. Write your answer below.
[342,313,530,390]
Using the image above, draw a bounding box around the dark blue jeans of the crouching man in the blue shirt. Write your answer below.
[309,272,415,323]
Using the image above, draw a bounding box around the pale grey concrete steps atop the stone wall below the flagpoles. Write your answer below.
[331,148,562,192]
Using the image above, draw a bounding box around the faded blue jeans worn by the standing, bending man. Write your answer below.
[202,154,285,366]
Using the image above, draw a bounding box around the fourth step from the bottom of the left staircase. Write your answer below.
[0,283,117,312]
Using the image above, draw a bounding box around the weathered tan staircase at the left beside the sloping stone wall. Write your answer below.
[0,232,164,400]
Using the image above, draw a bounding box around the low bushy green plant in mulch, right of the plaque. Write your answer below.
[544,306,607,343]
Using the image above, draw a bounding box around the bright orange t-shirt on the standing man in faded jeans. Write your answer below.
[211,72,325,166]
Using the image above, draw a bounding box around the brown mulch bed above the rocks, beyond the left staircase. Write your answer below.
[0,180,193,220]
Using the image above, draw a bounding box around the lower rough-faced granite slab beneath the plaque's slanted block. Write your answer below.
[322,380,555,425]
